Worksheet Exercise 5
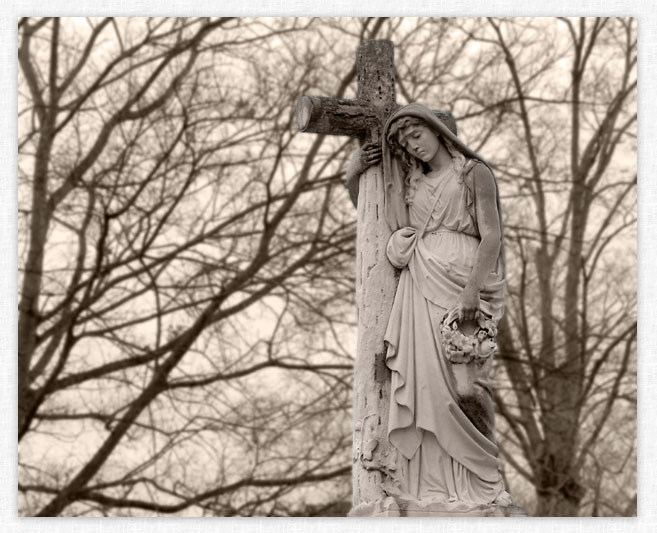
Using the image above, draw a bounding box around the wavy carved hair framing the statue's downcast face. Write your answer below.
[386,117,465,205]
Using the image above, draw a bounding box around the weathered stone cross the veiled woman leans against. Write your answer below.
[296,41,399,516]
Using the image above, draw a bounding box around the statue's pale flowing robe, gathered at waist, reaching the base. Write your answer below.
[385,163,504,504]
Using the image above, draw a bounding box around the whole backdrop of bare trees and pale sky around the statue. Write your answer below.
[19,19,636,516]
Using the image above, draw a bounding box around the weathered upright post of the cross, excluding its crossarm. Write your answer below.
[353,41,397,507]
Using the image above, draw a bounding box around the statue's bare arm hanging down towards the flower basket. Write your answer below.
[457,164,502,320]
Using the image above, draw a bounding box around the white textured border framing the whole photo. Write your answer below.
[5,0,657,533]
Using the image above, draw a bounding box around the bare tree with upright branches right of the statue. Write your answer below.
[456,19,636,516]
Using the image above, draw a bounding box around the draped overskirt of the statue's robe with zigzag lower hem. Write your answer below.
[386,270,499,474]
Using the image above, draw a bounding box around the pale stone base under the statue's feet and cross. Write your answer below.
[349,496,527,517]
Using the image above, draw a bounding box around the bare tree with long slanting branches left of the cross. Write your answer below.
[19,19,392,516]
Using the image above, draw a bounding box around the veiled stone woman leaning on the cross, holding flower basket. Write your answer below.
[348,104,511,506]
